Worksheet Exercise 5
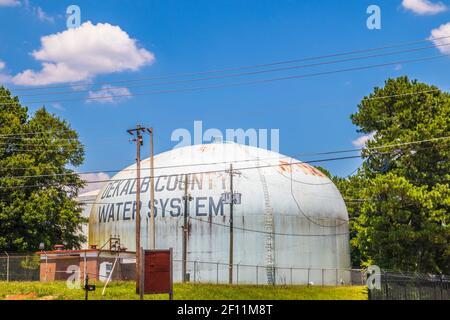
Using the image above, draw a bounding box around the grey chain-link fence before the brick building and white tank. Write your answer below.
[0,252,366,286]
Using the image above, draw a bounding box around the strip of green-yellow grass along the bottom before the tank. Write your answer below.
[0,282,367,300]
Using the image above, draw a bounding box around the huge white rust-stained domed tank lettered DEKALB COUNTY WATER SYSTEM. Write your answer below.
[89,143,350,285]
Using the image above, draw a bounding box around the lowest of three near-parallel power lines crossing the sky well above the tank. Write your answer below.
[2,54,447,105]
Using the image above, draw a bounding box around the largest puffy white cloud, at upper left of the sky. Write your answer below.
[13,21,155,85]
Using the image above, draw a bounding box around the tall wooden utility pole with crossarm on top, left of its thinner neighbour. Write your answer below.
[127,125,145,300]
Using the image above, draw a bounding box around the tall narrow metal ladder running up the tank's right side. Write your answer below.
[258,168,275,285]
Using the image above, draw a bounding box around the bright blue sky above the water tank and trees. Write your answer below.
[0,0,450,189]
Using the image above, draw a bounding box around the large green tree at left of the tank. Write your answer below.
[0,87,86,251]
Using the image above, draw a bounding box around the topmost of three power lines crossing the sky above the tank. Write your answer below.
[4,36,450,91]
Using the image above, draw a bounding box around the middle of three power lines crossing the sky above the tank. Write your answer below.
[0,43,450,98]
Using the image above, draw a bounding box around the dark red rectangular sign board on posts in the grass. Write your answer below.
[143,249,173,299]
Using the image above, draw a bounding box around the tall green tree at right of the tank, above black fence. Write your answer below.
[337,77,450,273]
